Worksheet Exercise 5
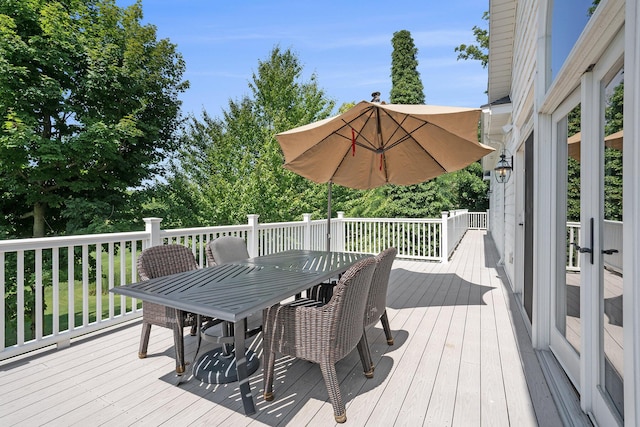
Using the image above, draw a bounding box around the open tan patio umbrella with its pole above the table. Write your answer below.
[276,101,494,250]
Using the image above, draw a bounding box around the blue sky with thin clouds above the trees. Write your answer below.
[117,0,488,116]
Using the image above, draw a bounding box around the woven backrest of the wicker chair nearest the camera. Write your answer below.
[321,257,376,360]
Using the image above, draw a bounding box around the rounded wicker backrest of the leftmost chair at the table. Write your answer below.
[138,244,199,280]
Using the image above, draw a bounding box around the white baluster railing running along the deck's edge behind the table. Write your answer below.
[0,211,486,360]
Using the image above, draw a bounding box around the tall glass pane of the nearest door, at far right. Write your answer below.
[601,67,624,417]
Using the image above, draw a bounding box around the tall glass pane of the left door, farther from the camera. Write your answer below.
[556,105,582,354]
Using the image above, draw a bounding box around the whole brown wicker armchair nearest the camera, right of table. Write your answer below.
[263,257,376,423]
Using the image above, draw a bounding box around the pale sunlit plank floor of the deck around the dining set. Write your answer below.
[0,231,562,426]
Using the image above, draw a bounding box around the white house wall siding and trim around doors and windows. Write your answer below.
[483,0,640,425]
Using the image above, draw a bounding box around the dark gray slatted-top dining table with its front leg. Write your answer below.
[111,250,371,415]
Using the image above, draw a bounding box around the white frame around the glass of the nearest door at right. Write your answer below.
[580,31,629,425]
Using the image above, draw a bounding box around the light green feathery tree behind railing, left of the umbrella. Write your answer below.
[156,47,334,226]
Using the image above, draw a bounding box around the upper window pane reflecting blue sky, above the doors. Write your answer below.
[551,0,599,79]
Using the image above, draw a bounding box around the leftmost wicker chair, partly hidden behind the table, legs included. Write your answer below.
[137,244,199,374]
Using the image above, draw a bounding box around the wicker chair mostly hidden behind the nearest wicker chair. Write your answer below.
[358,247,398,378]
